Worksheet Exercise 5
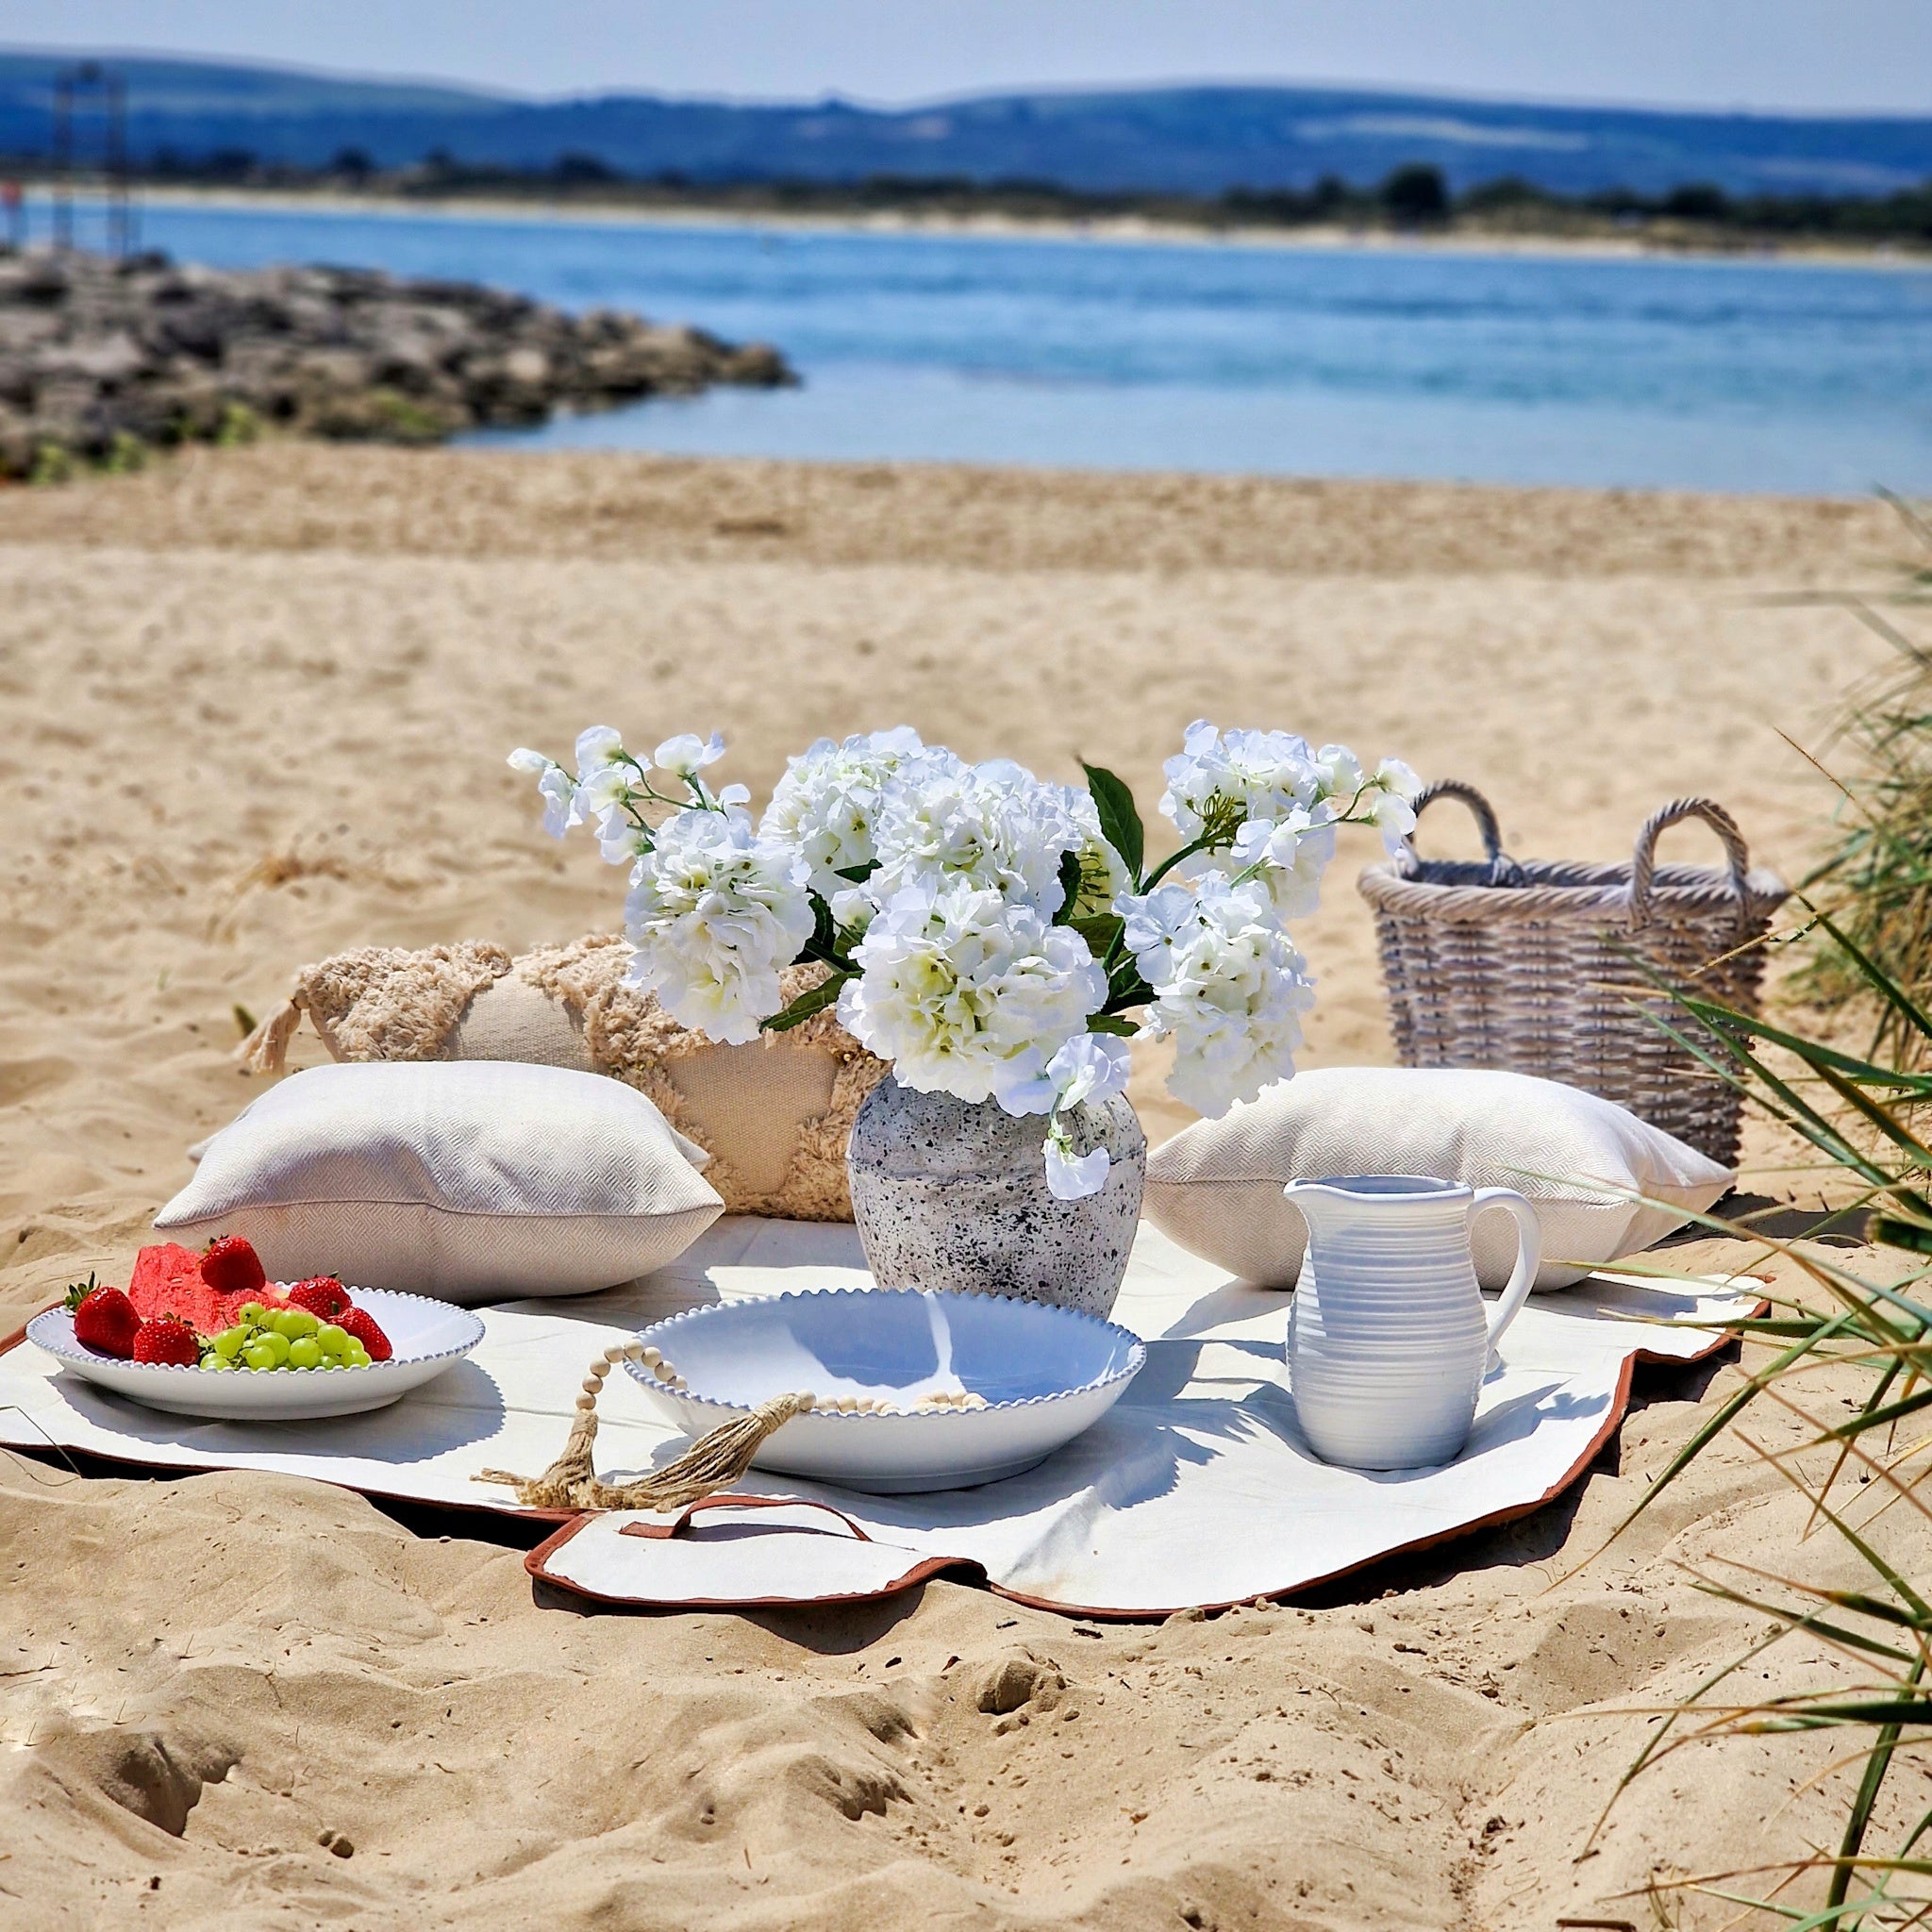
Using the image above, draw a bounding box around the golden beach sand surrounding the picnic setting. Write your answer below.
[0,446,1924,1932]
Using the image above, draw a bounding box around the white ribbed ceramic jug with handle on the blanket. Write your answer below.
[1285,1174,1541,1468]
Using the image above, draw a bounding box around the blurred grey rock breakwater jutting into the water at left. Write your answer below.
[0,253,796,477]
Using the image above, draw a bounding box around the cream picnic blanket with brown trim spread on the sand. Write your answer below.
[0,1217,1755,1615]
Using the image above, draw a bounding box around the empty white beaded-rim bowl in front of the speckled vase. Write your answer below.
[625,1289,1145,1493]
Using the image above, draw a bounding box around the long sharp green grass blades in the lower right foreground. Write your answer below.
[1606,911,1932,1932]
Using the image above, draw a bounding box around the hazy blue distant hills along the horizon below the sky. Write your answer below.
[0,52,1932,195]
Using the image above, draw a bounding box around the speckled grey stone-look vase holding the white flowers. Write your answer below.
[846,1074,1148,1316]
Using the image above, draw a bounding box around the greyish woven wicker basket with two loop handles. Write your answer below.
[1360,778,1787,1167]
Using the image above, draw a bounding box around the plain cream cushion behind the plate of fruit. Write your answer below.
[155,1060,724,1302]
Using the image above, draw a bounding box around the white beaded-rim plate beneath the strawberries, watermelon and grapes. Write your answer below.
[27,1283,483,1422]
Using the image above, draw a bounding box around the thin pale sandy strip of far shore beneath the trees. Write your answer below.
[83,188,1932,271]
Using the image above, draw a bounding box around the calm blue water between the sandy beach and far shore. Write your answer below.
[83,205,1932,492]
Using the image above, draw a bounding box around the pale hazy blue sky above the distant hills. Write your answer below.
[0,0,1932,114]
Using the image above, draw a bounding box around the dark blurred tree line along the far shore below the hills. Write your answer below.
[15,147,1932,245]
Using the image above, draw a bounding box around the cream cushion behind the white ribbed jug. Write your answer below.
[1141,1066,1735,1289]
